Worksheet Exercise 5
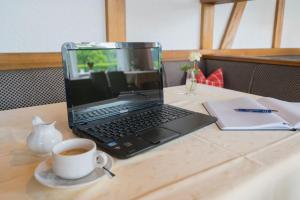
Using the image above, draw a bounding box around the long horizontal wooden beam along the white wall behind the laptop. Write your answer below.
[0,48,300,71]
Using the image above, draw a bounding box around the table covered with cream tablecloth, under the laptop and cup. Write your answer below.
[0,85,300,200]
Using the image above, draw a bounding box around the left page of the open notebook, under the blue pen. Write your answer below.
[205,97,289,129]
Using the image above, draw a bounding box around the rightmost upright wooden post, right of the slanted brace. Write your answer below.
[272,0,285,48]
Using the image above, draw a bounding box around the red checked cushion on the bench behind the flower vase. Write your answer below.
[196,68,224,87]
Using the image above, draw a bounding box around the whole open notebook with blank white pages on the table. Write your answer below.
[203,97,300,130]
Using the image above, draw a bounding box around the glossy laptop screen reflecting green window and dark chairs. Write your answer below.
[62,43,163,127]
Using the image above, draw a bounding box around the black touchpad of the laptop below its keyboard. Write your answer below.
[141,128,179,144]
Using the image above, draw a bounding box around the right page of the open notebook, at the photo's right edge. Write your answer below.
[257,97,300,129]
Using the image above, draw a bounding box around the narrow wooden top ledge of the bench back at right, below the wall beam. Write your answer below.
[203,55,300,67]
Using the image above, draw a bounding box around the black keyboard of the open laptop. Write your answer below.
[79,105,192,143]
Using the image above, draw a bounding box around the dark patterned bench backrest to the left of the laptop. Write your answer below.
[0,68,65,110]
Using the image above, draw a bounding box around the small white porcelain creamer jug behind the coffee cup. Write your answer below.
[27,116,63,154]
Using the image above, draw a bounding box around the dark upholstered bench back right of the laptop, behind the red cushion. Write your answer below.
[165,56,300,102]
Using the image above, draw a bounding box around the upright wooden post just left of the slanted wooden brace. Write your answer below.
[200,4,215,49]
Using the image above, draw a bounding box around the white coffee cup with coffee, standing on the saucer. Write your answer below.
[52,138,108,179]
